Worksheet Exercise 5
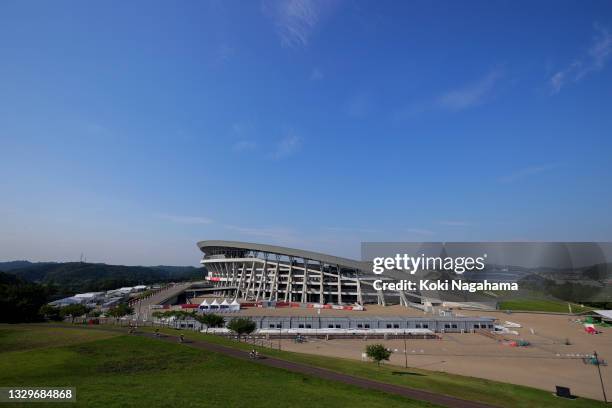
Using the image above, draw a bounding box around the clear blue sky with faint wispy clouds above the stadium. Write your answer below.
[0,0,612,265]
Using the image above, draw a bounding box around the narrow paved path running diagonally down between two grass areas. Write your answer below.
[139,332,493,408]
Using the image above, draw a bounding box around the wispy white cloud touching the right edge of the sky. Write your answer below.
[549,24,612,94]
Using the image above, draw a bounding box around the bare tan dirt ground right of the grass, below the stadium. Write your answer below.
[282,312,612,399]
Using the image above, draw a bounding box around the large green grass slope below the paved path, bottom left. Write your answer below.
[0,325,438,408]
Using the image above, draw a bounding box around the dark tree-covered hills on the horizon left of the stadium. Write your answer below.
[1,261,206,298]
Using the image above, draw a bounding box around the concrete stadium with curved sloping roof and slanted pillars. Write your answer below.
[198,241,420,306]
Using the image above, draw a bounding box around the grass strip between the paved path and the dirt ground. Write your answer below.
[141,329,605,408]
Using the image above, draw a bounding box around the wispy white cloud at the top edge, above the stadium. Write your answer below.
[262,0,337,47]
